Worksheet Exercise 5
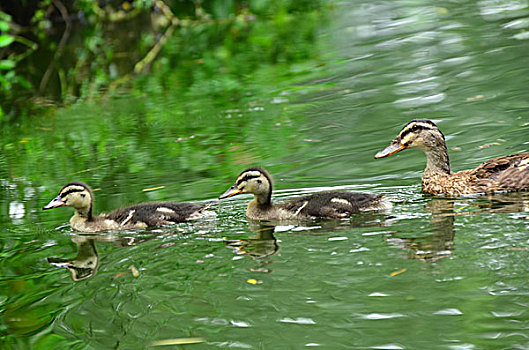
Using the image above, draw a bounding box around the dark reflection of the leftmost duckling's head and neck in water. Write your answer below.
[48,236,99,282]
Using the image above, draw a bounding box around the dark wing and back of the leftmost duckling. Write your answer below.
[106,202,210,227]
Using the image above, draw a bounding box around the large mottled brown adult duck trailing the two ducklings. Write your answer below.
[375,119,529,196]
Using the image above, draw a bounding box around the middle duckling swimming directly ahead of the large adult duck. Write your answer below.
[219,167,391,220]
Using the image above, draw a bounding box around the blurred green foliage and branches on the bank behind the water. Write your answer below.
[0,0,325,121]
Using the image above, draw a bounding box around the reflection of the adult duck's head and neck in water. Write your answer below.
[390,198,455,262]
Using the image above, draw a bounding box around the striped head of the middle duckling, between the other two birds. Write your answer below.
[219,167,272,204]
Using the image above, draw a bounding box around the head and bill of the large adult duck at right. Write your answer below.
[375,119,446,159]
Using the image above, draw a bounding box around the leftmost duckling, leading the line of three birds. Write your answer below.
[42,182,211,232]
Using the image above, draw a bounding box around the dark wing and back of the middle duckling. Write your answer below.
[282,192,382,218]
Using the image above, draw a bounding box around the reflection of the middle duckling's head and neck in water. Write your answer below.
[226,223,279,262]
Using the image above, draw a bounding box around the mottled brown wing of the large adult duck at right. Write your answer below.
[474,152,529,191]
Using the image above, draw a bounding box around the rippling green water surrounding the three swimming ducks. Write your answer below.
[0,1,529,349]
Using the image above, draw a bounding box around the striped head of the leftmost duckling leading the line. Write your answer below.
[42,182,93,219]
